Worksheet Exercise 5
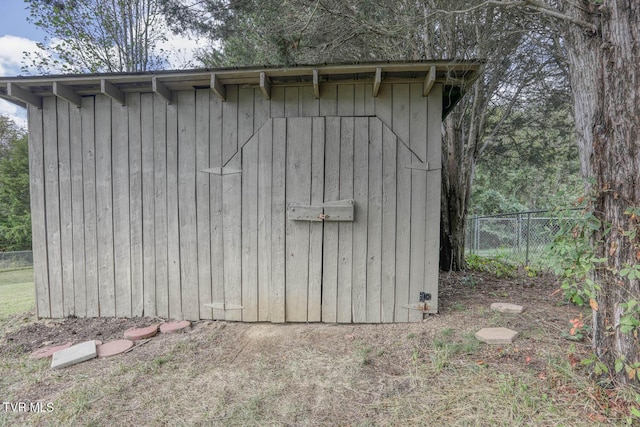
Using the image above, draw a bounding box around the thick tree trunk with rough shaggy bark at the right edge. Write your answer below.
[567,0,640,382]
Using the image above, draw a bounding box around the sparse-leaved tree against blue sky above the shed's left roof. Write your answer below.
[23,0,167,74]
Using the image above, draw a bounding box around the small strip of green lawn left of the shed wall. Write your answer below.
[0,267,35,319]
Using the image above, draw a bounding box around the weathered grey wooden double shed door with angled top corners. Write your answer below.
[213,117,439,323]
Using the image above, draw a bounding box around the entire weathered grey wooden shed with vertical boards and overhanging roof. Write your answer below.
[0,62,478,323]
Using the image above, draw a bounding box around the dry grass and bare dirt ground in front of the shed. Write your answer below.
[0,272,630,426]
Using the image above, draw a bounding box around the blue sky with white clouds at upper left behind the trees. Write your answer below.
[0,0,202,127]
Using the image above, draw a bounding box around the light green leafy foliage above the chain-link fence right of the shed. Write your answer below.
[469,101,583,215]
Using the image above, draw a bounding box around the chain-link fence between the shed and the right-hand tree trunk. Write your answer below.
[465,210,577,265]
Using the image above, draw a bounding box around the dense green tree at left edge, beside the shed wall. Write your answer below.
[0,120,31,251]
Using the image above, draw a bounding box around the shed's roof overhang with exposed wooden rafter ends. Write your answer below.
[0,60,482,118]
